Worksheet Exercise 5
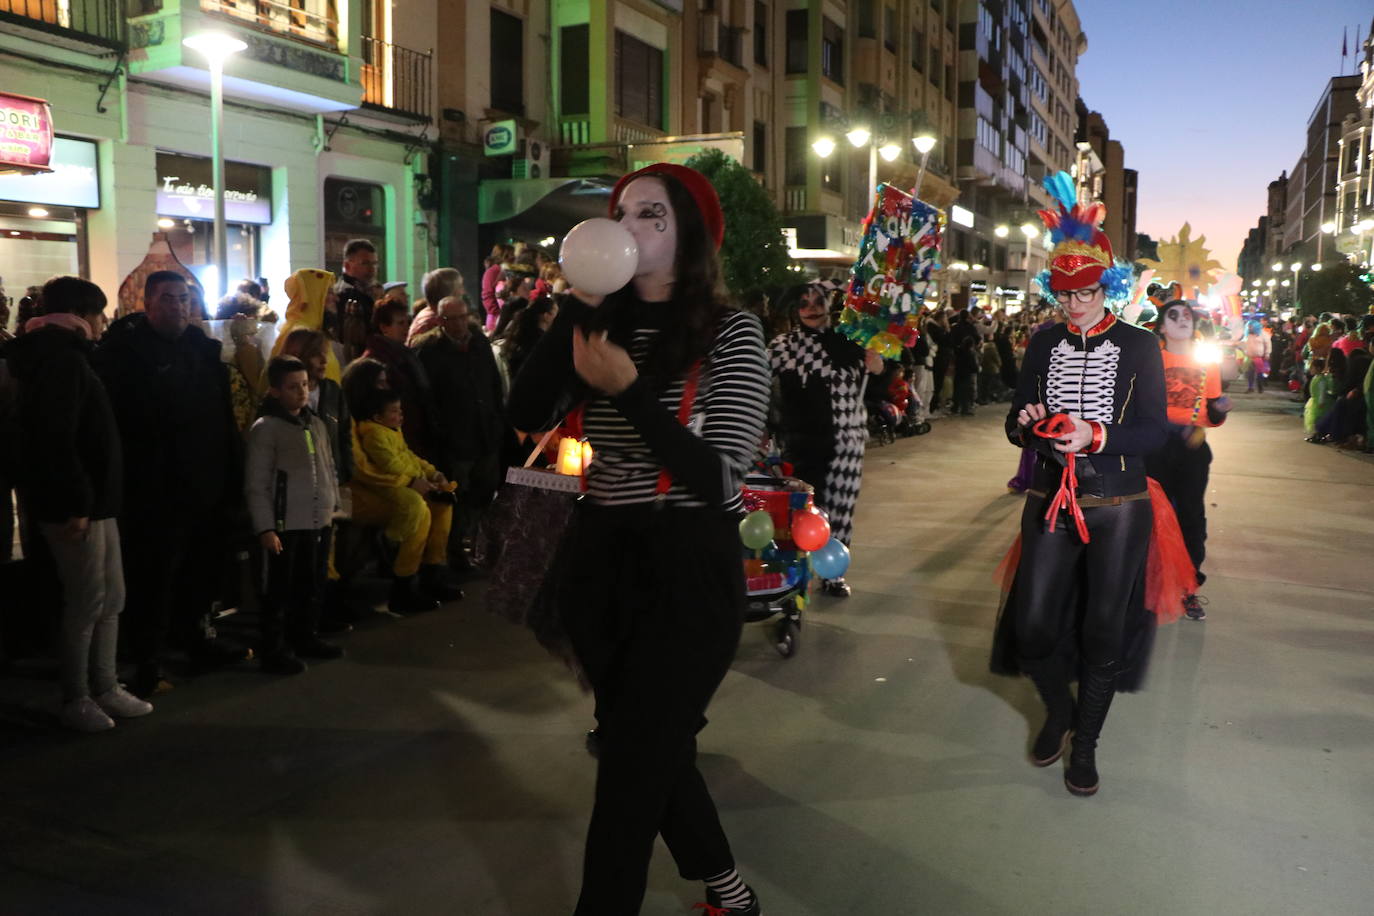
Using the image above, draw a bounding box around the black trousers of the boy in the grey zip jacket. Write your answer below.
[258,527,333,655]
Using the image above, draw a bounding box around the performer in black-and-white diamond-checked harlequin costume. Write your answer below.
[768,284,882,597]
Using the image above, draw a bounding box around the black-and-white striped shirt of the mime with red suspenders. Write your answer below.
[510,304,771,512]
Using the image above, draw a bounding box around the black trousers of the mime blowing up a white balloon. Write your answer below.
[558,507,745,916]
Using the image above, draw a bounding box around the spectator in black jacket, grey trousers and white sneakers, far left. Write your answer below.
[4,276,153,732]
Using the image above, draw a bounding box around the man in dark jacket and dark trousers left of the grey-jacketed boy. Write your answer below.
[95,271,247,696]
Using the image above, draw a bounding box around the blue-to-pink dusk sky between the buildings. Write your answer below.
[1076,0,1374,271]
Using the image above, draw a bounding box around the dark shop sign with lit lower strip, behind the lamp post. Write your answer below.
[157,152,272,225]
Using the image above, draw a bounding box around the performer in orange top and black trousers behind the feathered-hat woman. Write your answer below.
[1145,299,1231,621]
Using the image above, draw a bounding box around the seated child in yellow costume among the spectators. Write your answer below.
[349,390,463,614]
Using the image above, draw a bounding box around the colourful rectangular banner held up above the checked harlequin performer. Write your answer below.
[838,184,944,360]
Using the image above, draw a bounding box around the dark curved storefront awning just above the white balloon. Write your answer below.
[477,179,613,238]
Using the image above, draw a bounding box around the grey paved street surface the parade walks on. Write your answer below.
[0,394,1374,916]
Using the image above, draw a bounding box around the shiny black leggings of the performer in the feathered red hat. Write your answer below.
[1015,496,1154,665]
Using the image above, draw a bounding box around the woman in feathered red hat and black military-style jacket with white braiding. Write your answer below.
[992,172,1187,795]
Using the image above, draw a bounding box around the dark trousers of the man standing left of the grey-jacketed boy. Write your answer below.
[120,512,225,665]
